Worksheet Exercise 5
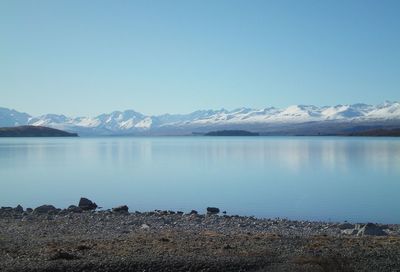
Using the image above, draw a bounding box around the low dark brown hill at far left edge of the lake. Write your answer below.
[0,126,78,137]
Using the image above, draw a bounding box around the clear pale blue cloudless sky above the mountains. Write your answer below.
[0,0,400,116]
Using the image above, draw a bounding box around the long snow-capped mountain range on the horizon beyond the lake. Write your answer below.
[0,102,400,135]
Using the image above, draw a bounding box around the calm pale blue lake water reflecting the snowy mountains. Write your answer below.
[0,137,400,223]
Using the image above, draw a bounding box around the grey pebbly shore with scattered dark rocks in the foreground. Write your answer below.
[0,198,400,271]
